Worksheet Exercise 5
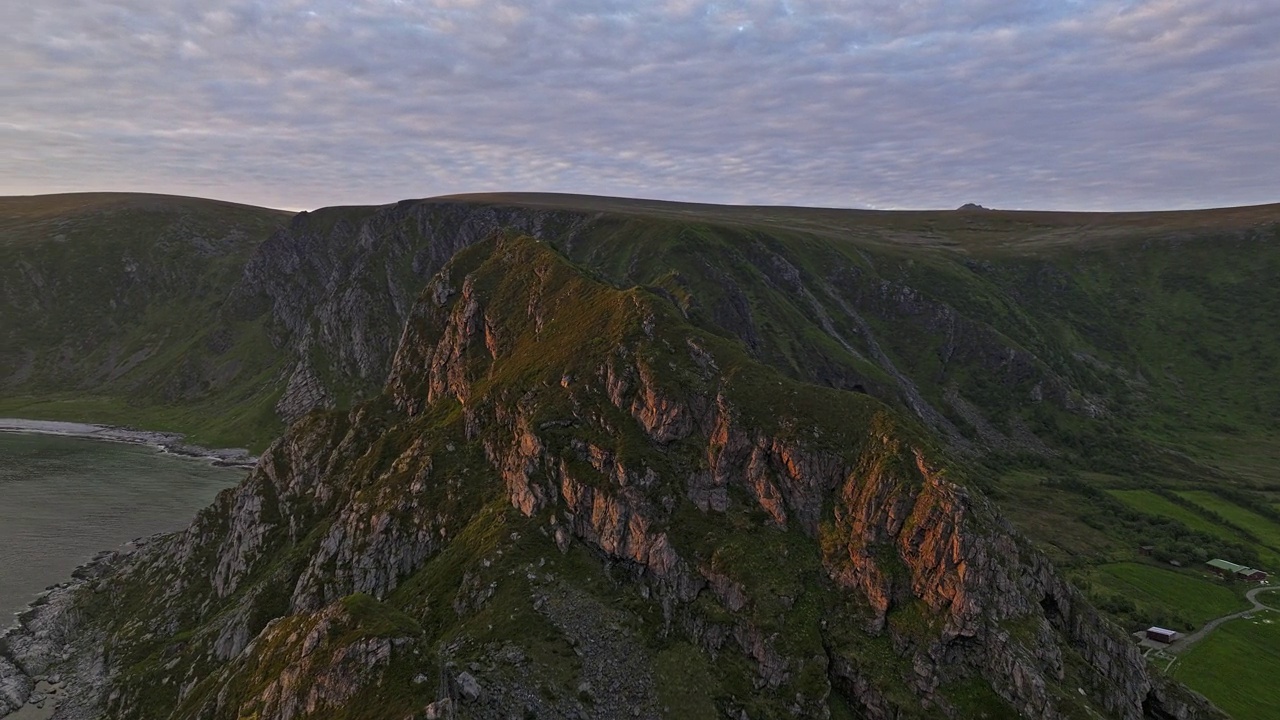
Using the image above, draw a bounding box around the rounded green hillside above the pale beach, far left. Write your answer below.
[0,193,289,446]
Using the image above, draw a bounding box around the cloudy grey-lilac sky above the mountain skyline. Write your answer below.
[0,0,1280,210]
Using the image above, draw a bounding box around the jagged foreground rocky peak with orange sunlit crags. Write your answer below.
[0,233,1216,719]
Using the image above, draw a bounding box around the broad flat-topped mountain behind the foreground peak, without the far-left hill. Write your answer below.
[197,196,1280,464]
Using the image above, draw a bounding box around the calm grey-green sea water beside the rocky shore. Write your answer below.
[0,433,246,622]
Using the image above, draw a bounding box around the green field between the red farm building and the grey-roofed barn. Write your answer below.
[1088,562,1249,630]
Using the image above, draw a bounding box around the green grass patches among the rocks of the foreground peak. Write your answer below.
[91,233,1018,717]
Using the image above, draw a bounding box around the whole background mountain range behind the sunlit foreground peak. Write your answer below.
[0,190,1280,464]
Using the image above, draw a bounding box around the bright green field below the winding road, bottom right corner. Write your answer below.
[1172,612,1280,720]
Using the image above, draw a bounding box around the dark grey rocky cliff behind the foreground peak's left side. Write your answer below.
[227,201,591,423]
